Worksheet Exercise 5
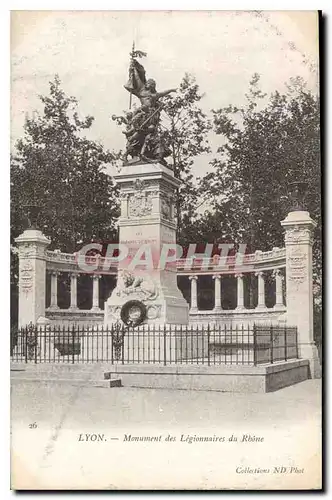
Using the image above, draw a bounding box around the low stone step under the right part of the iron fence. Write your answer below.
[104,359,309,393]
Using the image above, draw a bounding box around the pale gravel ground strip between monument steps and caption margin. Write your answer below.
[12,380,321,427]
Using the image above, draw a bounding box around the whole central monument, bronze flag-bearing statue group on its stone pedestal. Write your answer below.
[105,49,189,325]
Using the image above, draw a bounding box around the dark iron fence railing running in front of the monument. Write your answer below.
[11,323,298,365]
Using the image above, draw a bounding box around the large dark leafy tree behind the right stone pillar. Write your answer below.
[200,75,321,332]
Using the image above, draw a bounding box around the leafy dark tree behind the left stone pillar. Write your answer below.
[11,76,118,252]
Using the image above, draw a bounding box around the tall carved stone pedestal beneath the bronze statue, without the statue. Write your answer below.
[105,163,189,324]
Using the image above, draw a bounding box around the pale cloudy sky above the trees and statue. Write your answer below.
[11,11,318,180]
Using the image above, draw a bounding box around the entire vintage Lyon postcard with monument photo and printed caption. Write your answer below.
[10,10,322,491]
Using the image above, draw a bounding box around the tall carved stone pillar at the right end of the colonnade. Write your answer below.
[281,210,321,378]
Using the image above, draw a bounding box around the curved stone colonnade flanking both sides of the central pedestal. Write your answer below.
[41,248,286,322]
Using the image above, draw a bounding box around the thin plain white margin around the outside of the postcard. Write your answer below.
[0,0,332,498]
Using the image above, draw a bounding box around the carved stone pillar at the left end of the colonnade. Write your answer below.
[15,229,50,327]
